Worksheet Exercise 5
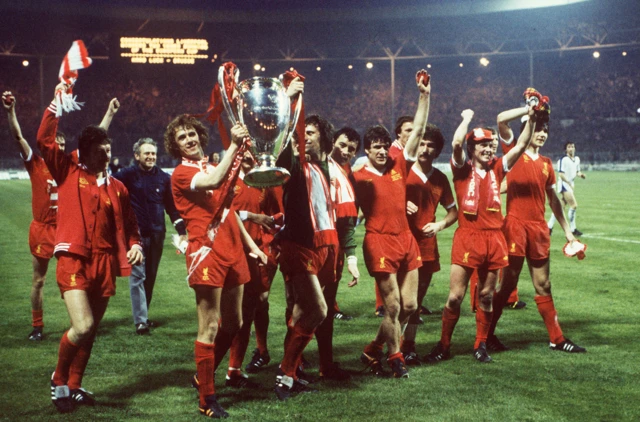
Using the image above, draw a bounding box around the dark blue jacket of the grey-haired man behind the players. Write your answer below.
[113,163,187,237]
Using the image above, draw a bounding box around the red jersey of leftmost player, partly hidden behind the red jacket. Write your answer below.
[24,150,58,225]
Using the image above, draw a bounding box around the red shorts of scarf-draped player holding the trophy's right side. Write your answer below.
[280,240,336,286]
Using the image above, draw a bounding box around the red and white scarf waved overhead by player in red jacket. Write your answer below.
[54,40,92,117]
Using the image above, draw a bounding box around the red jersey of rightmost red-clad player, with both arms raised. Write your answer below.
[507,151,556,221]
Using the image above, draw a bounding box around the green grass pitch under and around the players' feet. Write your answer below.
[0,172,640,421]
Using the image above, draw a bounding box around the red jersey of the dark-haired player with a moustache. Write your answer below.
[407,164,456,239]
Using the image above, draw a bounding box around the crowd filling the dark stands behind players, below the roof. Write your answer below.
[0,53,640,168]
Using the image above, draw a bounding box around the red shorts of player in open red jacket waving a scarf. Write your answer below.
[56,252,118,297]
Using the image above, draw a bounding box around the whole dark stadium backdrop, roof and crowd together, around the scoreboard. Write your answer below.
[0,0,640,168]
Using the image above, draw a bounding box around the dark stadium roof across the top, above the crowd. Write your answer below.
[0,0,640,61]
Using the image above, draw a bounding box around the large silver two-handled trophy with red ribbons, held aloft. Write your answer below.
[218,66,302,187]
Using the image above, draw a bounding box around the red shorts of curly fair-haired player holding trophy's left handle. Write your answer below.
[187,246,251,288]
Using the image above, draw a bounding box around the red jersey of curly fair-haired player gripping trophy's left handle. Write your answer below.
[171,159,244,265]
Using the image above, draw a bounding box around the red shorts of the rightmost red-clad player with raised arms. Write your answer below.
[502,216,551,260]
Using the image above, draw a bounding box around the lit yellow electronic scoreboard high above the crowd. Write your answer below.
[120,37,209,64]
